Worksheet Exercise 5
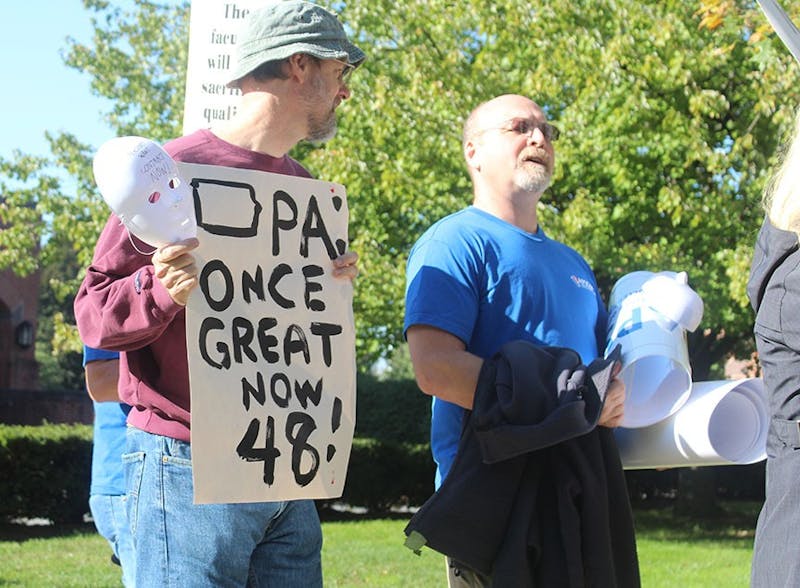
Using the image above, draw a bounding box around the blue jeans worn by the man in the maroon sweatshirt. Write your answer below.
[122,427,322,588]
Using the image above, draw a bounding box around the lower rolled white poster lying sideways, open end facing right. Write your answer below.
[615,378,769,470]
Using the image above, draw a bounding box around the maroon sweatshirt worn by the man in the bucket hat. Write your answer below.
[75,130,311,441]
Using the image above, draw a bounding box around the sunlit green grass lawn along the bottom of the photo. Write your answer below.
[0,503,758,588]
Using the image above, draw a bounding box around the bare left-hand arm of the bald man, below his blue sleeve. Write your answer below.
[406,325,483,409]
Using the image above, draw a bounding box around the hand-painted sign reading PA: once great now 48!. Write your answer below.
[179,163,355,503]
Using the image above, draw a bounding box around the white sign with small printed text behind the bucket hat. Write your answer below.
[183,0,264,135]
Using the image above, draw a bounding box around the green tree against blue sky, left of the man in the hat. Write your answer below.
[0,0,188,387]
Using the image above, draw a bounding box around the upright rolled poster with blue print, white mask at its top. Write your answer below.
[606,271,703,427]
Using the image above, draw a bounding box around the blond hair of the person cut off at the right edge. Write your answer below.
[764,111,800,237]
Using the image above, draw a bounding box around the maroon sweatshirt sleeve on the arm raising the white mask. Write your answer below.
[74,214,183,351]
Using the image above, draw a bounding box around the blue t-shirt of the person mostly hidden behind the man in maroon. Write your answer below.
[83,345,131,496]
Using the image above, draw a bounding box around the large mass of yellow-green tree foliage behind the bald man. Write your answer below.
[322,0,798,379]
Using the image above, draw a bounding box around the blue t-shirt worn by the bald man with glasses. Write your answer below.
[404,206,607,488]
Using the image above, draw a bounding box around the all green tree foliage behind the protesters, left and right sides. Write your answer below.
[0,0,800,374]
